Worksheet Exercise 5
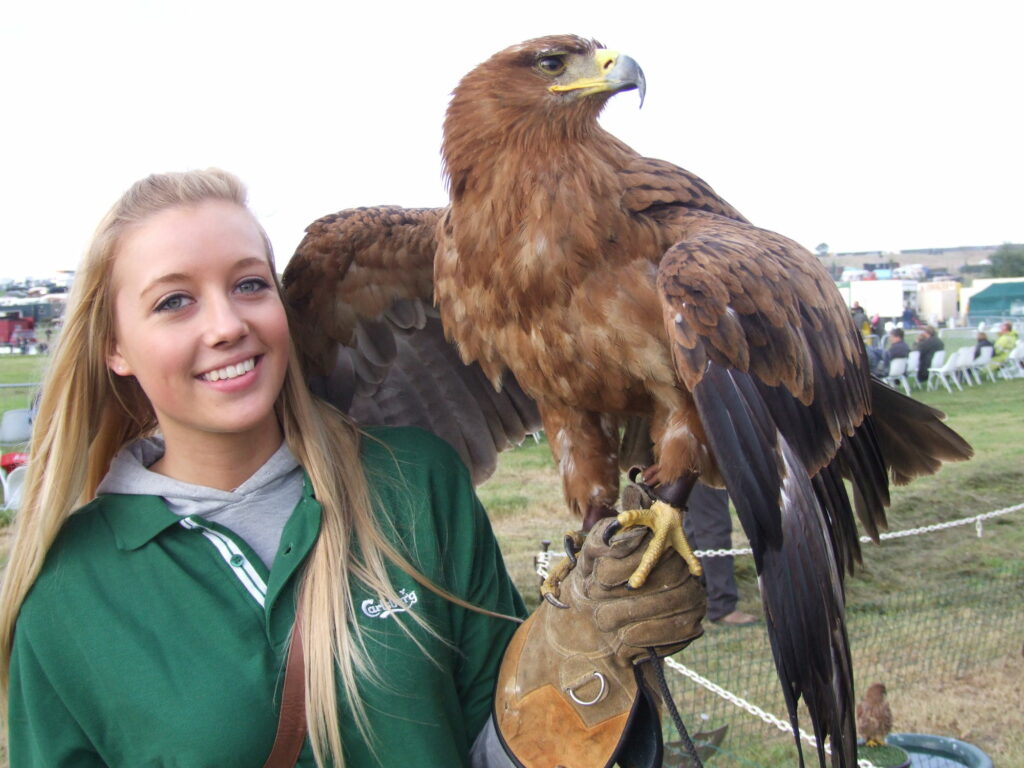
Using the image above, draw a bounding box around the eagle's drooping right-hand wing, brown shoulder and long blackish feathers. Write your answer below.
[657,211,872,765]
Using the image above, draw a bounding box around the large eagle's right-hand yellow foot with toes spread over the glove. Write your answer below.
[605,472,703,589]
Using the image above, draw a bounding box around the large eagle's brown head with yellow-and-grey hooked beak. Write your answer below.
[442,35,646,189]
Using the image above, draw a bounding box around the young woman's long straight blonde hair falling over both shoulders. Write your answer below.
[0,169,444,767]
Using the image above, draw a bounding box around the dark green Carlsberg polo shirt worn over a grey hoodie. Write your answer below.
[8,429,524,768]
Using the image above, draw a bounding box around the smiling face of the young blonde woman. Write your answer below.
[106,200,290,449]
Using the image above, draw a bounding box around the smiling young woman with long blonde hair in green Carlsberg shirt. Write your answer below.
[0,170,699,768]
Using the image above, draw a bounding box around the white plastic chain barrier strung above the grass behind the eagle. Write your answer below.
[534,504,1024,768]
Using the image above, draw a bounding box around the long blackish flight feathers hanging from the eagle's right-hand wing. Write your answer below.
[693,364,856,765]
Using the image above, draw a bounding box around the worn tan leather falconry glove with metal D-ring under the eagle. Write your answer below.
[495,517,707,768]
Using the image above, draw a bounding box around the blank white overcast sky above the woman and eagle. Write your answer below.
[0,0,1024,278]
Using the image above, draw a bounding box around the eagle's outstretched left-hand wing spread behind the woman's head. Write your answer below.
[284,206,540,482]
